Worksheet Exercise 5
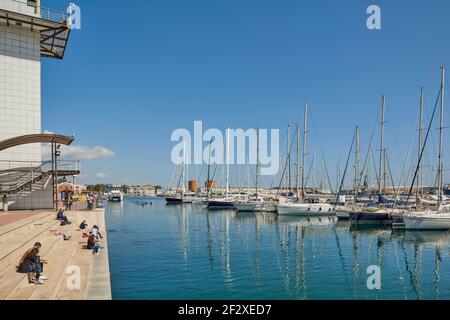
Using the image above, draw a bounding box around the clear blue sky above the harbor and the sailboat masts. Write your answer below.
[42,0,450,185]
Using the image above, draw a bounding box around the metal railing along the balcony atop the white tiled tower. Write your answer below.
[0,0,68,23]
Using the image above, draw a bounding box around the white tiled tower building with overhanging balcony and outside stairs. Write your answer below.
[0,0,71,209]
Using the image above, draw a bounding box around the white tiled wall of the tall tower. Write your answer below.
[0,0,42,167]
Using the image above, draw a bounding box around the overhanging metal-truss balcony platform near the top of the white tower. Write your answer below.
[0,9,70,59]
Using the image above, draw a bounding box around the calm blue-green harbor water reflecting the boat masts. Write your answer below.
[106,197,450,300]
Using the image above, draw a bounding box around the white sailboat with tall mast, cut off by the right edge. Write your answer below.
[403,65,450,230]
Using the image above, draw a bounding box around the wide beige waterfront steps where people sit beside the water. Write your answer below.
[0,210,111,300]
